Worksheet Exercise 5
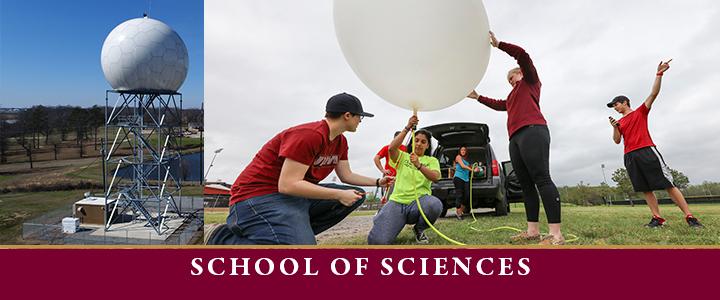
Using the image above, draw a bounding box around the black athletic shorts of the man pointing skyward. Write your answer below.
[625,147,675,192]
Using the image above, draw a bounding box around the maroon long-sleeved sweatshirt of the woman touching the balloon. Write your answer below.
[478,42,547,138]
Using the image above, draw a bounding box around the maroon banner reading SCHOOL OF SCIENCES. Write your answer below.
[0,248,720,299]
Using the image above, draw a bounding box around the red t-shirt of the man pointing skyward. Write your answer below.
[618,103,655,154]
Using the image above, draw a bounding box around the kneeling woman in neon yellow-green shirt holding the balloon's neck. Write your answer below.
[368,116,443,245]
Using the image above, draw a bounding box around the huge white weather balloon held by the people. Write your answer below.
[334,0,490,111]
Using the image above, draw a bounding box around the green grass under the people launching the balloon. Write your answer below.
[205,204,720,246]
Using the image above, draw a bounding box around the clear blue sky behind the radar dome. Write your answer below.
[0,0,204,108]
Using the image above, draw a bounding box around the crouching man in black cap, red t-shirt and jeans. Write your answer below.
[206,93,393,245]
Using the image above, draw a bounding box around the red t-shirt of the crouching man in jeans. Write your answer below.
[230,120,348,205]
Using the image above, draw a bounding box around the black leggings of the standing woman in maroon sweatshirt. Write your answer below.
[510,125,560,224]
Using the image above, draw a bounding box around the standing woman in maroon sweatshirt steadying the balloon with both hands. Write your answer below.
[468,31,565,245]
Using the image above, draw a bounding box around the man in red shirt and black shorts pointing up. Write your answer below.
[607,59,702,228]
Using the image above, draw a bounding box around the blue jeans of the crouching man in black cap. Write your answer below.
[208,184,365,245]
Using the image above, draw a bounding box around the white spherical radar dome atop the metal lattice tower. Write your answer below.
[100,17,188,92]
